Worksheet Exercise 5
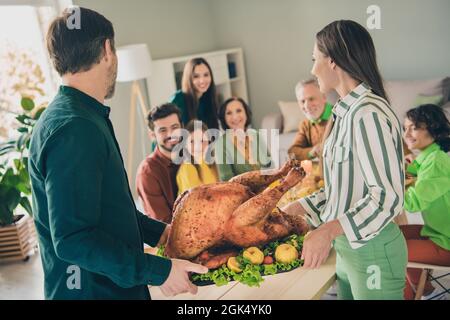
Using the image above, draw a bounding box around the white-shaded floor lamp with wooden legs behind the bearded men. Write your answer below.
[117,44,152,179]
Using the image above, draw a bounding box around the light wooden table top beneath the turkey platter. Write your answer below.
[150,250,336,300]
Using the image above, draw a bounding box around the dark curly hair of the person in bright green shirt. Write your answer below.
[406,104,450,152]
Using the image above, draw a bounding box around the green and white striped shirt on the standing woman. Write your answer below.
[299,83,405,249]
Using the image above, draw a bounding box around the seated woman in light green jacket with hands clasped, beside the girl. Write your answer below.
[215,97,271,181]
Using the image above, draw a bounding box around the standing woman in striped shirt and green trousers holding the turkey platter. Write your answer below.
[285,20,407,299]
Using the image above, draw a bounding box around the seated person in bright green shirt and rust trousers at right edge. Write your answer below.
[401,104,450,299]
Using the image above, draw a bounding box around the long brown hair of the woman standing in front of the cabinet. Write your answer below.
[181,58,219,129]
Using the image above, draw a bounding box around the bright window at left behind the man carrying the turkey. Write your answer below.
[0,1,60,142]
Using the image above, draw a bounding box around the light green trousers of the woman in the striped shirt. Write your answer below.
[334,223,408,300]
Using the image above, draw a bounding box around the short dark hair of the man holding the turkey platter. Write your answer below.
[47,7,115,76]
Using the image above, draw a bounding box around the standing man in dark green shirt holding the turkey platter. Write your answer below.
[29,8,207,299]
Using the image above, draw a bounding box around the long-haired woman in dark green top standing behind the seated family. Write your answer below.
[169,58,219,129]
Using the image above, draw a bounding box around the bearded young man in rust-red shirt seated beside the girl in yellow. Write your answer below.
[136,103,185,223]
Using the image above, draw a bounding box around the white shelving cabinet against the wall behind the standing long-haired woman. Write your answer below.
[148,48,249,106]
